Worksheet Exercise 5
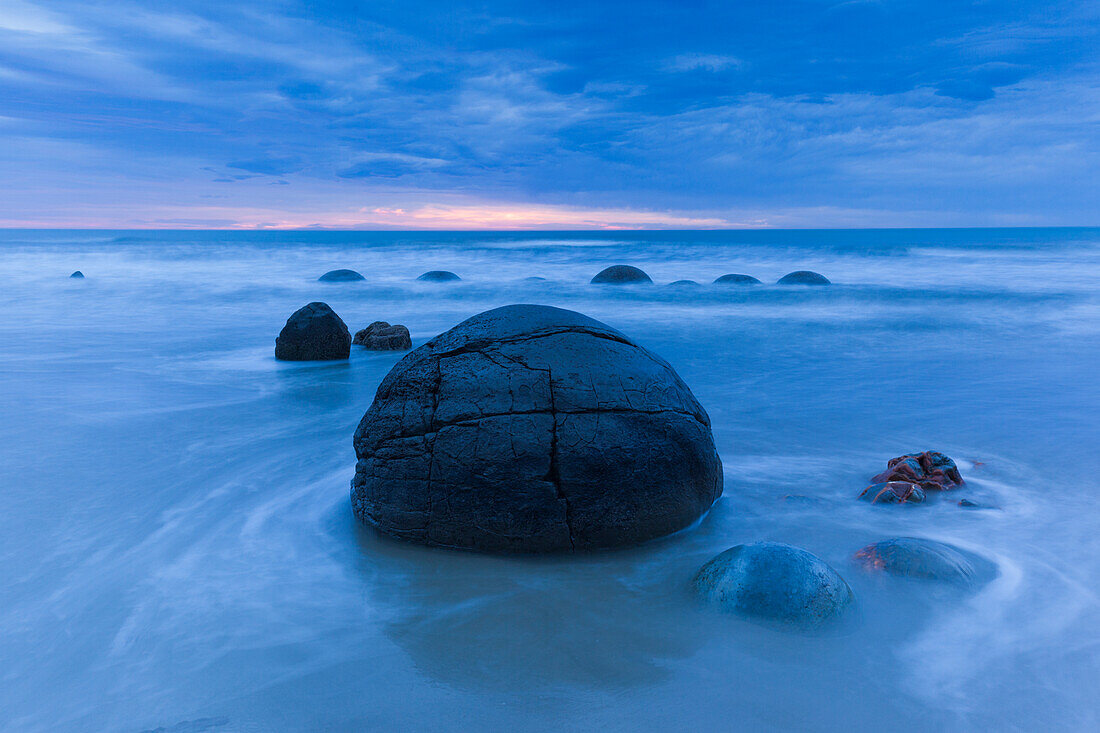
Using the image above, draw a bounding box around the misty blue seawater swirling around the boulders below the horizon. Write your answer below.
[0,229,1100,732]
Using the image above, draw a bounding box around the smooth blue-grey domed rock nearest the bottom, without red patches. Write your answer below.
[694,543,854,627]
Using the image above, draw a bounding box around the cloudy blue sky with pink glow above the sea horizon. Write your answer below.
[0,0,1100,229]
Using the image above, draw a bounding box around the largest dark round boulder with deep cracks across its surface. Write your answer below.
[351,305,722,553]
